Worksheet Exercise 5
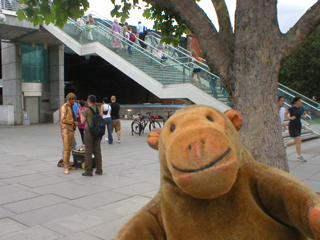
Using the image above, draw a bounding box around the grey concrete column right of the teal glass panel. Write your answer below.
[50,45,64,110]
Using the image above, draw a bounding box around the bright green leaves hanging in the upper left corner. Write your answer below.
[17,0,89,28]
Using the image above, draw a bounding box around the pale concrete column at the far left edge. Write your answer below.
[1,43,22,124]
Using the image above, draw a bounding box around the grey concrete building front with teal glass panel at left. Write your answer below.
[2,43,64,124]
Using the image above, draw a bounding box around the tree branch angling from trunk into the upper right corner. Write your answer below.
[281,0,320,57]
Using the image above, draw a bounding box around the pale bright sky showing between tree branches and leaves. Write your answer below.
[88,0,317,33]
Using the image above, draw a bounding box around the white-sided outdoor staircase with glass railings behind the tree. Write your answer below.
[45,13,320,139]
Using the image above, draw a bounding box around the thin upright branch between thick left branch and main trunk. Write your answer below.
[211,0,234,52]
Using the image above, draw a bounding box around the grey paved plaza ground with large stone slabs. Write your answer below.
[0,120,320,240]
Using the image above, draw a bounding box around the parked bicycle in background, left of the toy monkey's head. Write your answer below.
[131,112,162,136]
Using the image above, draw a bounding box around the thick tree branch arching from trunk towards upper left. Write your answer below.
[144,0,233,78]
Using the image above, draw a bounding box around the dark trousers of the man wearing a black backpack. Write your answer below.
[84,131,102,175]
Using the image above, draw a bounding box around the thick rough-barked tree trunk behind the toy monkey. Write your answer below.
[226,0,289,171]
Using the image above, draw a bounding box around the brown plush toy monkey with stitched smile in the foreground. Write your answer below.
[115,105,320,240]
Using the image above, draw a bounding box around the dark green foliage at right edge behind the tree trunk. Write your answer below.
[279,26,320,101]
